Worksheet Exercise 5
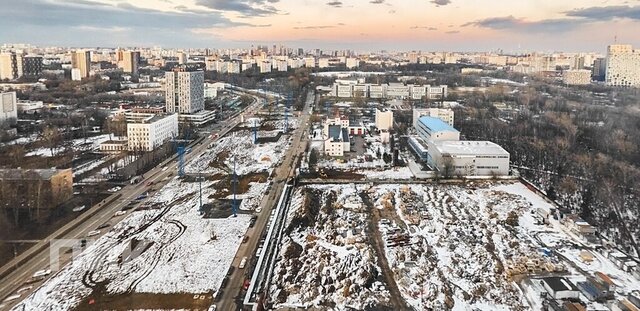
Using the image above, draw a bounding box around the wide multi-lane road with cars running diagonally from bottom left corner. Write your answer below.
[0,96,260,310]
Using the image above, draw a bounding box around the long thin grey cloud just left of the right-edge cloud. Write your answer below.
[461,16,585,33]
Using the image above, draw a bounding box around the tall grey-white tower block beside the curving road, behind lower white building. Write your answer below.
[165,68,204,114]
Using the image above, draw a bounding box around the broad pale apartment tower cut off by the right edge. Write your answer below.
[605,44,640,87]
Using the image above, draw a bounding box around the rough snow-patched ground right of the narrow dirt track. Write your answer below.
[369,182,640,310]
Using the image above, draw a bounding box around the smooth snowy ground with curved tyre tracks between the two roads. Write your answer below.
[16,178,250,310]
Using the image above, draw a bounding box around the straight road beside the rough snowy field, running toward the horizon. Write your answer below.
[216,92,315,311]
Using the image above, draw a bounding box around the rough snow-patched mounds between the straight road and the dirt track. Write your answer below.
[270,185,389,310]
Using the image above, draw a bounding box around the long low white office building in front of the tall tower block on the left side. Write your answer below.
[127,113,178,151]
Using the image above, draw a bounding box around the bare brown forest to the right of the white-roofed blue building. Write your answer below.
[455,81,640,254]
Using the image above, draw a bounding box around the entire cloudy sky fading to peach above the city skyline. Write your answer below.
[0,0,640,53]
